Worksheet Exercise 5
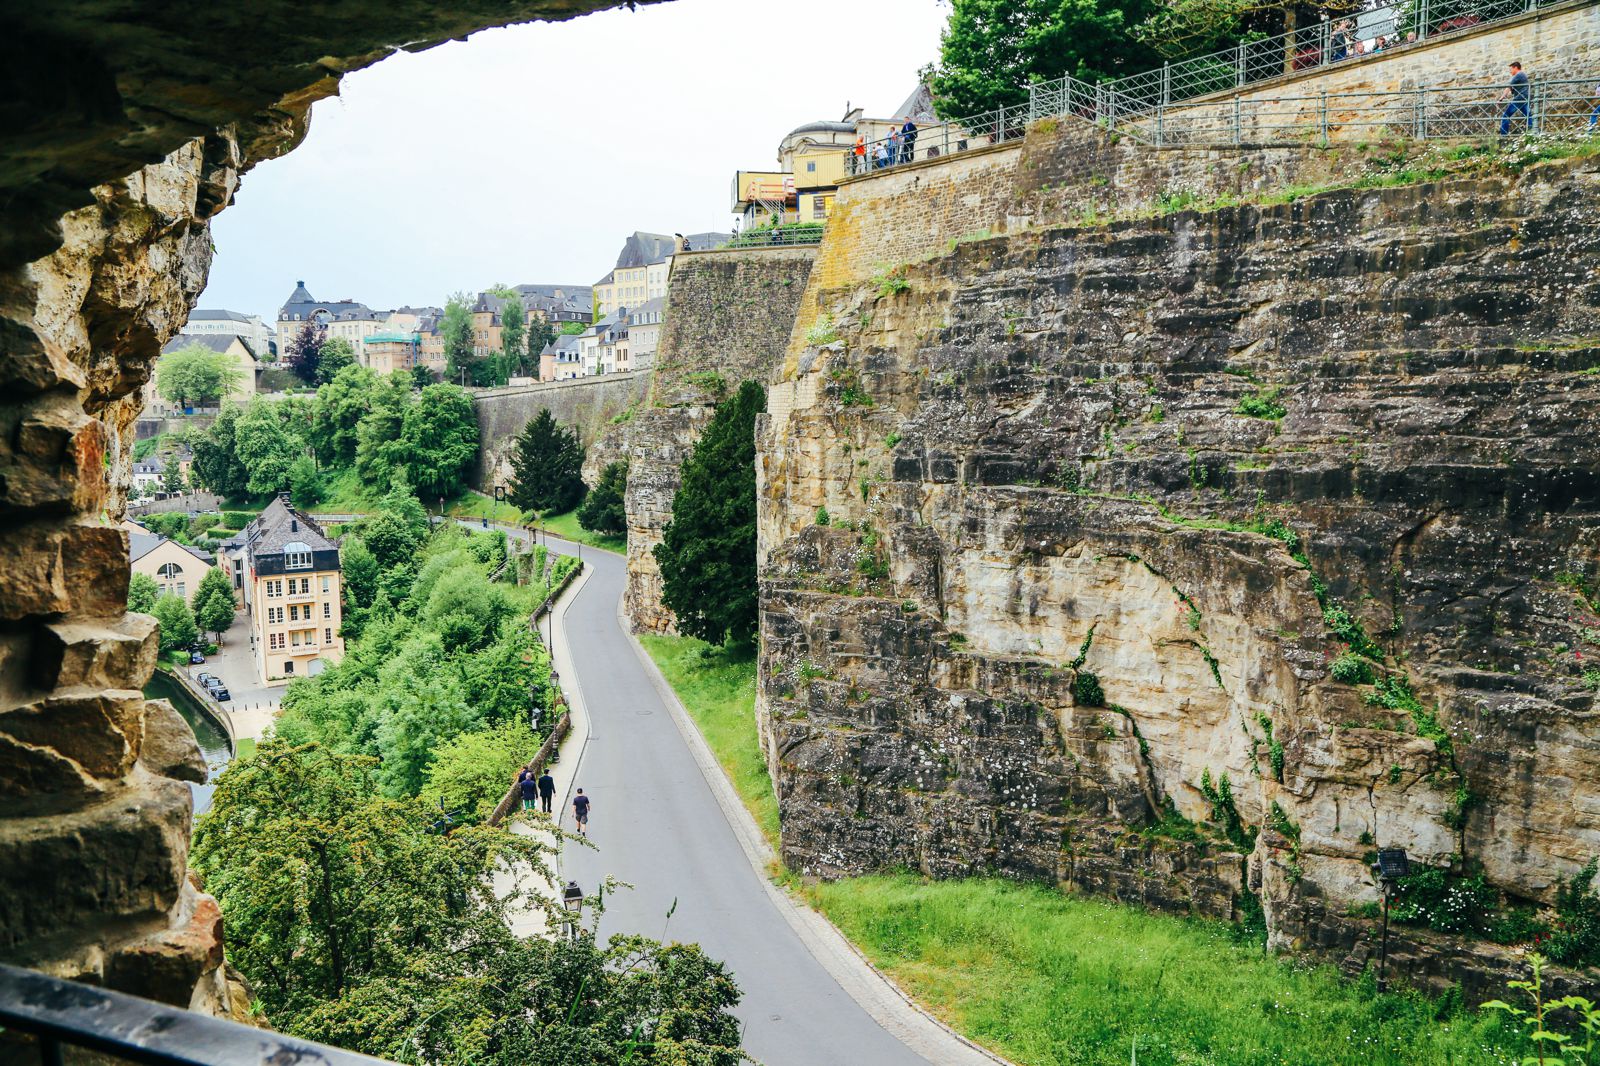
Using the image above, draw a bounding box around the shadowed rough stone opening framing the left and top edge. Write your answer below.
[0,0,636,1016]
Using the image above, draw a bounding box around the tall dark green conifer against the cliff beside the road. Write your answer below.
[654,381,766,643]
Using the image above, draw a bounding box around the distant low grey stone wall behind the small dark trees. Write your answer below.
[472,370,651,491]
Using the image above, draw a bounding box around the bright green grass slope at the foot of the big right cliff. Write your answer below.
[800,874,1517,1066]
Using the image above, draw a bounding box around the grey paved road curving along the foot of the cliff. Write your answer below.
[528,534,926,1066]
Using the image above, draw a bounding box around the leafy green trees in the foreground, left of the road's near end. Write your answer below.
[194,743,739,1066]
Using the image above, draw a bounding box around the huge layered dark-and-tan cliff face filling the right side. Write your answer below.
[758,136,1600,991]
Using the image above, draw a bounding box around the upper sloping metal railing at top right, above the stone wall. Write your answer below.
[1094,0,1566,117]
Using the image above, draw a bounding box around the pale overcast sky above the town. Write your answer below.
[198,0,947,322]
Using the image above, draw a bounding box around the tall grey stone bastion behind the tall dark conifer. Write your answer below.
[611,248,816,632]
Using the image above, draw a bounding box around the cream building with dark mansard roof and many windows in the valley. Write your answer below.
[243,496,344,685]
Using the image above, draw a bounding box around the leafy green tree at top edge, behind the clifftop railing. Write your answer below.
[930,0,1162,118]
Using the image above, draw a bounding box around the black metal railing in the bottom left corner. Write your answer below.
[0,964,384,1066]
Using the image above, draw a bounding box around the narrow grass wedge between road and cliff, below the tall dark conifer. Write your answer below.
[638,635,778,848]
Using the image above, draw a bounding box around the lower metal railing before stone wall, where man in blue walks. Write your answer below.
[1118,75,1600,147]
